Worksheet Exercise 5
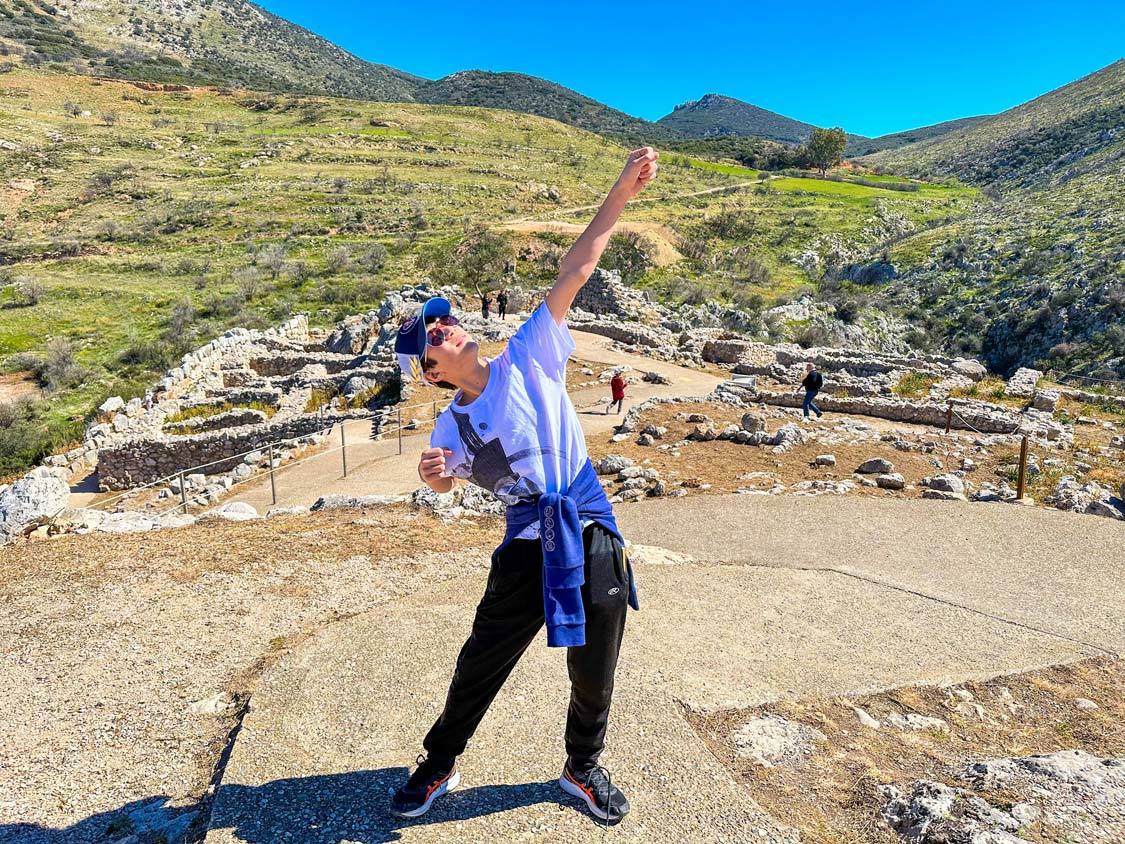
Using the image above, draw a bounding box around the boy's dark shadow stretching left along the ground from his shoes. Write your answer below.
[0,766,597,844]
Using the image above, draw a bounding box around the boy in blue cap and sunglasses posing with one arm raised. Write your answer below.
[390,147,657,823]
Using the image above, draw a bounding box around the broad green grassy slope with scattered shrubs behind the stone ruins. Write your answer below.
[0,68,973,474]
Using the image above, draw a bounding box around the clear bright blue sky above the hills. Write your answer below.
[258,0,1125,136]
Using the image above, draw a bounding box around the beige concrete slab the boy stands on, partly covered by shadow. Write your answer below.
[207,544,1088,844]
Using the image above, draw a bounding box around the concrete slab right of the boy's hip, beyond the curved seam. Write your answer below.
[617,495,1125,655]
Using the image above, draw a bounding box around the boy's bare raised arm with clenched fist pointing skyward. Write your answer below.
[547,146,659,323]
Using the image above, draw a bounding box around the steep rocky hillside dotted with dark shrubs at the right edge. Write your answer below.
[851,61,1125,378]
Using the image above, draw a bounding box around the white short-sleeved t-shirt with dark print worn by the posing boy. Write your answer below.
[430,303,588,539]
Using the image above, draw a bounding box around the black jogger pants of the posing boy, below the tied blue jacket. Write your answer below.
[423,523,629,770]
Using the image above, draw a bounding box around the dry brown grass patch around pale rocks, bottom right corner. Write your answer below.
[689,658,1125,844]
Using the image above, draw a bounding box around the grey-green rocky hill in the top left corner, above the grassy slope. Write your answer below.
[0,0,424,101]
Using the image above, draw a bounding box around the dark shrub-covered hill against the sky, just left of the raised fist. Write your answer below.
[415,70,667,142]
